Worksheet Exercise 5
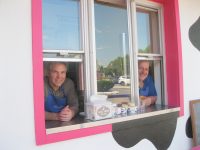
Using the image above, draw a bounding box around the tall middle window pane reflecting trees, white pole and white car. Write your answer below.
[95,0,130,102]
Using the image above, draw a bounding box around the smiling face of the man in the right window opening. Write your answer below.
[138,61,149,81]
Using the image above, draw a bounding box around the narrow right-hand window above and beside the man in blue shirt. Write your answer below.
[136,6,167,104]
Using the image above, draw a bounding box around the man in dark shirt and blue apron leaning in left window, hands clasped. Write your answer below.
[44,62,78,121]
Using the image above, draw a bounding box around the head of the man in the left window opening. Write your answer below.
[48,62,67,90]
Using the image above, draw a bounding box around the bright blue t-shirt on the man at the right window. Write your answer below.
[139,75,157,96]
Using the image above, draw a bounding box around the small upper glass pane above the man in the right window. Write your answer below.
[137,9,160,54]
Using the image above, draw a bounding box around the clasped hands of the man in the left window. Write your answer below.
[58,106,75,121]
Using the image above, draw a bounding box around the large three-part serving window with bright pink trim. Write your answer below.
[32,0,183,144]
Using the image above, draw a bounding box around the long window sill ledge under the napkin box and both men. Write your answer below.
[46,105,180,134]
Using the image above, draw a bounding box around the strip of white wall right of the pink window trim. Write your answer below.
[169,0,200,150]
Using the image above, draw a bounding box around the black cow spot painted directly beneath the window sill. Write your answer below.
[112,112,179,150]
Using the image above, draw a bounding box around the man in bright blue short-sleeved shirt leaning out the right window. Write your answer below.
[138,60,157,106]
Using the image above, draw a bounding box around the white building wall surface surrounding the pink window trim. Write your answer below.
[0,0,200,150]
